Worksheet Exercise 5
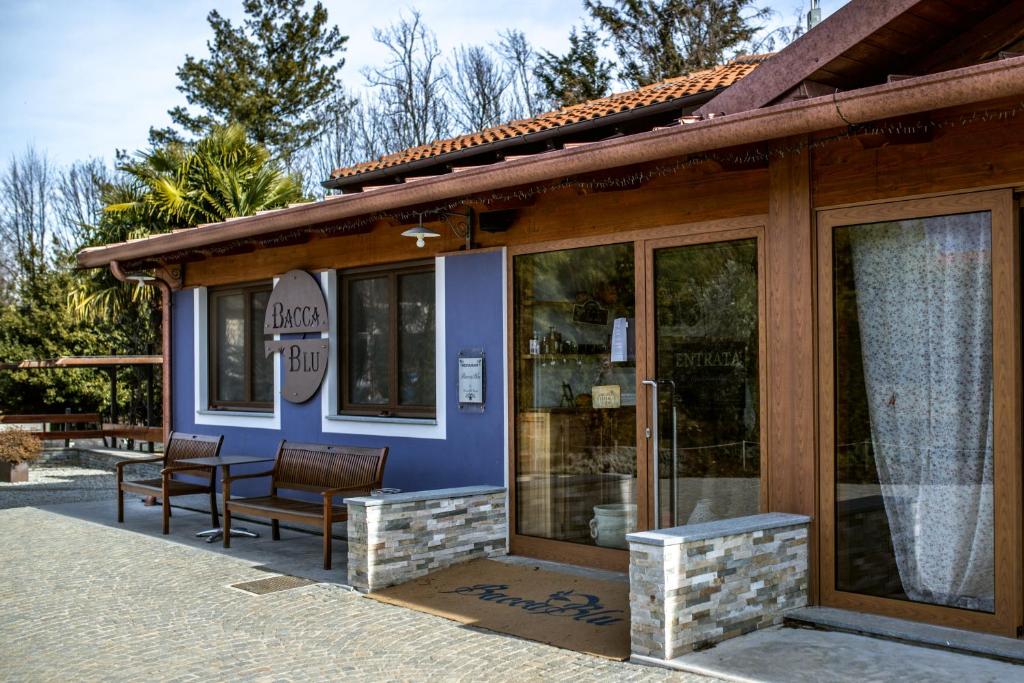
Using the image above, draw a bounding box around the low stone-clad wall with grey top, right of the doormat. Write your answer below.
[626,513,810,664]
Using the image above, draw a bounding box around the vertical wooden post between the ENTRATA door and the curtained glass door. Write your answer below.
[765,141,816,515]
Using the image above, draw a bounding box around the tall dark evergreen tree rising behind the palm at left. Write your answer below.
[151,0,348,167]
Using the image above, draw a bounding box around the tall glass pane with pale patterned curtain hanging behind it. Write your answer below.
[834,212,995,612]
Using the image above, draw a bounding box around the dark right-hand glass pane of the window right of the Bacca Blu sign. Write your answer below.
[398,271,436,405]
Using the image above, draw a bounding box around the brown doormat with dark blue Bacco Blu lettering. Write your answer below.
[367,560,630,659]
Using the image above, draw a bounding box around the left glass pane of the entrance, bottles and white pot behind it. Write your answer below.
[514,245,637,548]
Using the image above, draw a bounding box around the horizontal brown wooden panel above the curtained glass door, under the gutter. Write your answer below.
[812,100,1024,208]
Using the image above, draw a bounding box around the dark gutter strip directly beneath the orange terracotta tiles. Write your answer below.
[321,88,727,189]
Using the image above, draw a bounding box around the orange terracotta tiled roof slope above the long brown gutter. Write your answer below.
[331,54,770,178]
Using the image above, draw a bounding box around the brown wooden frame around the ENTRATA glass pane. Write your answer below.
[637,224,770,527]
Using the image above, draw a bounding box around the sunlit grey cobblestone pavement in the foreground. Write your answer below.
[0,508,708,682]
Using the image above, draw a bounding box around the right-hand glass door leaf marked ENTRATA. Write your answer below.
[642,230,763,528]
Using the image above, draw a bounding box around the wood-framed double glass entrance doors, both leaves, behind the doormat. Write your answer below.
[510,226,764,570]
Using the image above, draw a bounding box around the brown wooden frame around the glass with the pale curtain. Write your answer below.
[816,189,1024,637]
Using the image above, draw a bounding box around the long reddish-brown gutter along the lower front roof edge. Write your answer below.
[78,57,1024,267]
